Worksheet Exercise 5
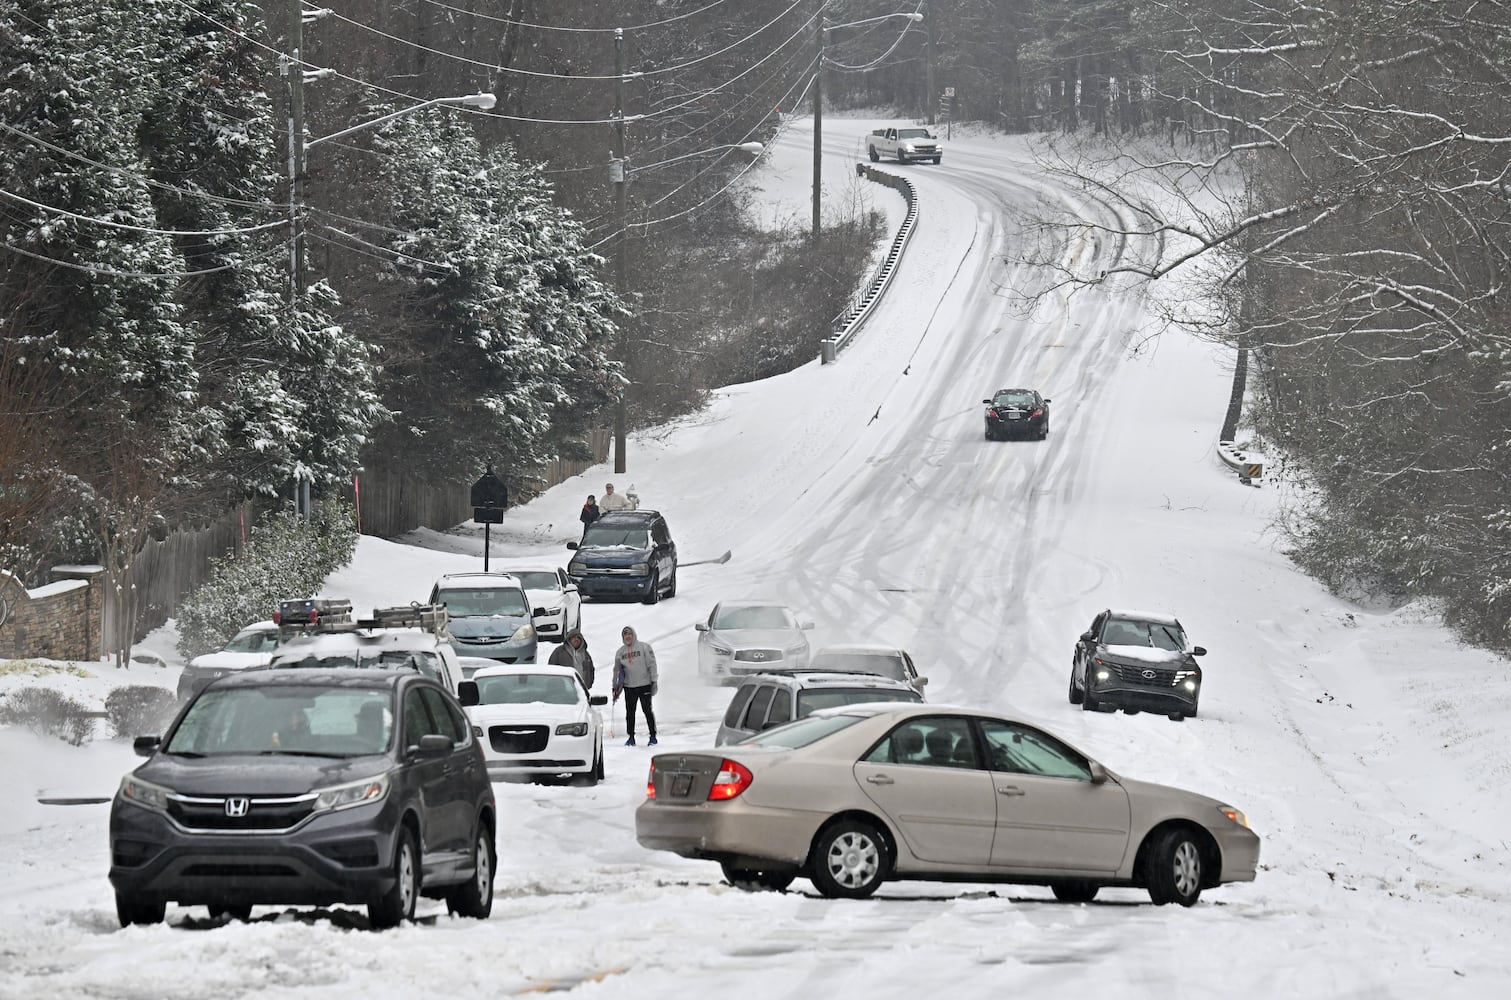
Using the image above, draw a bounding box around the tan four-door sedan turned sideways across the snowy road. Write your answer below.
[635,704,1259,906]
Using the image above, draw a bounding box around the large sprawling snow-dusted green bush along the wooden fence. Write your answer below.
[178,500,357,659]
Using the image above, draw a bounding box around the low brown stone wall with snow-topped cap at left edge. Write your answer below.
[0,566,104,660]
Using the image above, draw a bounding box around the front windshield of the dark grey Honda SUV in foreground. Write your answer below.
[163,684,393,757]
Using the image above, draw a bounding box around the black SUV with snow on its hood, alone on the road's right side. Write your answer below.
[1070,609,1206,722]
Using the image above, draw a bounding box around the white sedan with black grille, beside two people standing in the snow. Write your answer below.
[459,663,609,784]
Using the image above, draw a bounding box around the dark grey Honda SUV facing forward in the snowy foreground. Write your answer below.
[110,669,496,927]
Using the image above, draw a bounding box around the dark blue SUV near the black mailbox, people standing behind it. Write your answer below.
[567,511,677,604]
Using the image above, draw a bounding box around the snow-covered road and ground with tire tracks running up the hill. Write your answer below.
[0,119,1511,1000]
